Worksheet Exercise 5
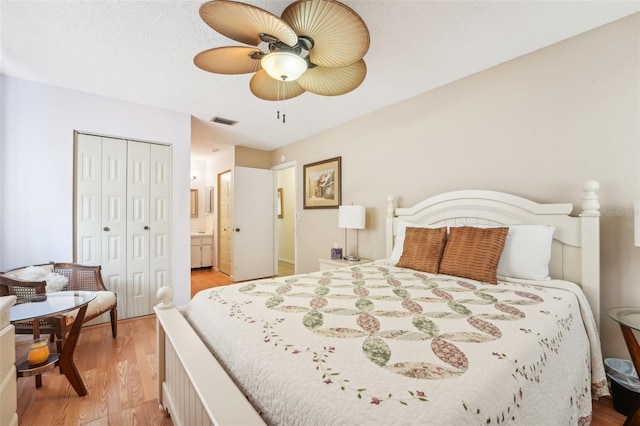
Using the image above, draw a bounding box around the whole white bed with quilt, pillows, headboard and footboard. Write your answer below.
[155,181,608,425]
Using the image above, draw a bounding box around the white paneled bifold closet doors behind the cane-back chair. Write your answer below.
[74,132,171,318]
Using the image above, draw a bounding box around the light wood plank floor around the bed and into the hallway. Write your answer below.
[17,269,625,426]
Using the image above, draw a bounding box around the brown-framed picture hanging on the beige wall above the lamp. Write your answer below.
[303,157,342,209]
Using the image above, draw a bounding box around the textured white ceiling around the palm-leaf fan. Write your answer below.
[0,0,640,159]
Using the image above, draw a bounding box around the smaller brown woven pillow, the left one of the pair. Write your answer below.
[396,227,447,274]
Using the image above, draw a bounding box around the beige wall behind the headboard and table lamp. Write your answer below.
[271,14,640,358]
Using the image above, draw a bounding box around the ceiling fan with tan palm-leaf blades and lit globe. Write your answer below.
[194,0,369,101]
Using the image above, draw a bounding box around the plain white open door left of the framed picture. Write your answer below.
[232,167,275,281]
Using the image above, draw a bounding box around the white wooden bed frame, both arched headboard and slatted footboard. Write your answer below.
[154,180,600,426]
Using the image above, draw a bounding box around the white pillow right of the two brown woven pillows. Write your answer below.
[497,225,555,281]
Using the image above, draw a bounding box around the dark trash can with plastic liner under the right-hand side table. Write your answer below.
[604,358,640,416]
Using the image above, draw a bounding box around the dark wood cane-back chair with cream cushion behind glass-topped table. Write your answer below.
[0,262,118,351]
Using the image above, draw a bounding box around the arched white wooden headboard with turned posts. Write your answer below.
[386,180,600,325]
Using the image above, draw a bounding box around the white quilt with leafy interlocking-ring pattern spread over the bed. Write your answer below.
[185,260,608,426]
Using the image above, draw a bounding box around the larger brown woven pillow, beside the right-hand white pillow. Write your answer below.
[440,226,509,284]
